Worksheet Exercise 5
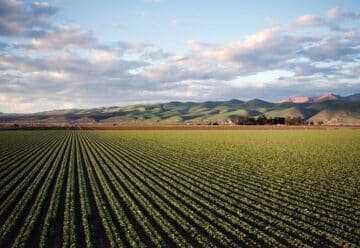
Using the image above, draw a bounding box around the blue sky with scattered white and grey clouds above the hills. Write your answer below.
[0,0,360,113]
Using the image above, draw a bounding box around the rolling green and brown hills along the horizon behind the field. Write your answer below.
[0,93,360,126]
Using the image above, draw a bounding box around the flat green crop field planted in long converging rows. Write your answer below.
[0,129,360,247]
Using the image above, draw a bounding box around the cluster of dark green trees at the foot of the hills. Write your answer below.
[232,115,314,125]
